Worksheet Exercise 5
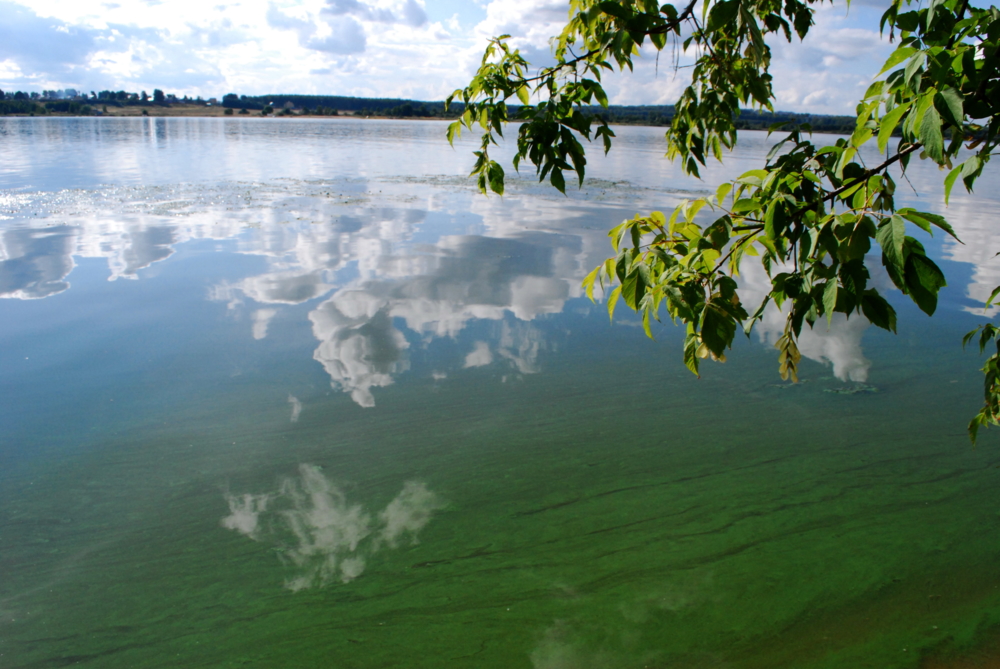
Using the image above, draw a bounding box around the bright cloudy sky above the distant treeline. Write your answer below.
[0,0,892,114]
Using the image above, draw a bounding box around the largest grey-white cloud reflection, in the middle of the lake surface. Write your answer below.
[300,233,580,407]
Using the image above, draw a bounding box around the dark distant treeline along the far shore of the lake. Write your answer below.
[0,89,855,135]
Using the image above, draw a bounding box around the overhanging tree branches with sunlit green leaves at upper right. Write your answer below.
[448,0,1000,441]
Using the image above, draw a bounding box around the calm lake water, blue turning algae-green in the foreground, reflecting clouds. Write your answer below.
[0,119,1000,669]
